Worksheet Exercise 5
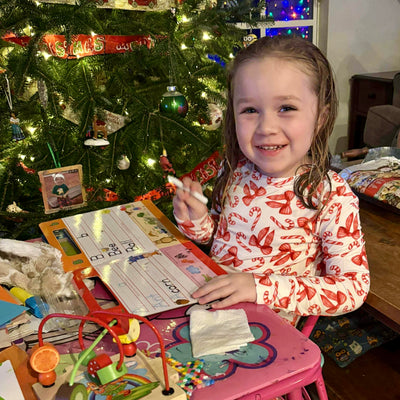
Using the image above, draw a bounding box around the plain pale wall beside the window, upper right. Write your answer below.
[319,0,400,153]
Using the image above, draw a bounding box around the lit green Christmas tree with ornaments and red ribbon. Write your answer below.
[0,0,266,240]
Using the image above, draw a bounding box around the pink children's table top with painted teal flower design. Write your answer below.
[137,303,321,400]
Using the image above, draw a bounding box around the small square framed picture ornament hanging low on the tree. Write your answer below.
[39,165,86,214]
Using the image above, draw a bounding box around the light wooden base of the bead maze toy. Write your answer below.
[32,351,186,400]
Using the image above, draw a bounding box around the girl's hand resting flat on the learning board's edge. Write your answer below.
[192,272,257,308]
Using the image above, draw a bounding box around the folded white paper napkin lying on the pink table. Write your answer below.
[190,309,255,358]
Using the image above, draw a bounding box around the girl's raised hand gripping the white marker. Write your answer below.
[172,177,208,221]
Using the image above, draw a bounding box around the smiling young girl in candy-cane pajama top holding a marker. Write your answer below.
[173,37,369,325]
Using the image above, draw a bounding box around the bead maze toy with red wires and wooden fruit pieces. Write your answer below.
[30,310,186,400]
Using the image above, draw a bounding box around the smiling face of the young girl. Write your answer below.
[233,57,318,178]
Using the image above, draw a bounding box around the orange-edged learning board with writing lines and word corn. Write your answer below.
[39,200,228,316]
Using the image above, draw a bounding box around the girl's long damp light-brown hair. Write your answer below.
[213,36,337,210]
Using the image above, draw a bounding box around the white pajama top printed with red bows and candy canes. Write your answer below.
[176,160,370,325]
